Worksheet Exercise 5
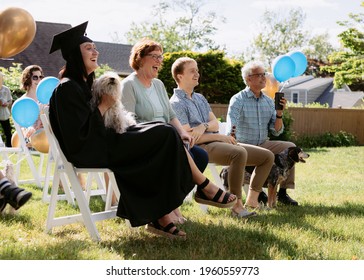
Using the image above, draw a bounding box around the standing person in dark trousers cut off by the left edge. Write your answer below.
[0,72,13,147]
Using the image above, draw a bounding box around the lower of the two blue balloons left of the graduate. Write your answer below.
[11,97,39,127]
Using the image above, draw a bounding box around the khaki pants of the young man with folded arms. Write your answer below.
[200,142,274,198]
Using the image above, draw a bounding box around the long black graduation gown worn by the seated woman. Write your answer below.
[49,80,194,226]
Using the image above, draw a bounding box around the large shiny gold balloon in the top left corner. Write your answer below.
[0,7,36,58]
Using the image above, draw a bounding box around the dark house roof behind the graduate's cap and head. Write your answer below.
[0,21,133,77]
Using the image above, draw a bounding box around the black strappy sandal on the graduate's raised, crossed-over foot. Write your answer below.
[194,178,236,208]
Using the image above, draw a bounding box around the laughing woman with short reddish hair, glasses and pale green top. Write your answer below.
[122,38,208,223]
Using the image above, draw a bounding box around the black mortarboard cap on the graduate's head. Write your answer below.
[49,21,92,60]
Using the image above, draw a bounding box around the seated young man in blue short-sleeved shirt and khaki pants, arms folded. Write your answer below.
[170,57,274,215]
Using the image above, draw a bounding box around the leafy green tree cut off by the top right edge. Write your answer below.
[322,2,364,90]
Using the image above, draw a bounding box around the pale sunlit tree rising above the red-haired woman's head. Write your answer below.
[126,0,225,52]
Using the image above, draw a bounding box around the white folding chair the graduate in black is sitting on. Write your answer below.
[41,111,128,241]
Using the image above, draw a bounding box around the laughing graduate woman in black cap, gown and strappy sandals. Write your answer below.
[49,22,236,238]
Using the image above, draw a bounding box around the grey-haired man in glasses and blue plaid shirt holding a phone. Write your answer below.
[227,61,298,206]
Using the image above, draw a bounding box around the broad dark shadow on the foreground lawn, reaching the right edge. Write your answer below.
[101,203,364,260]
